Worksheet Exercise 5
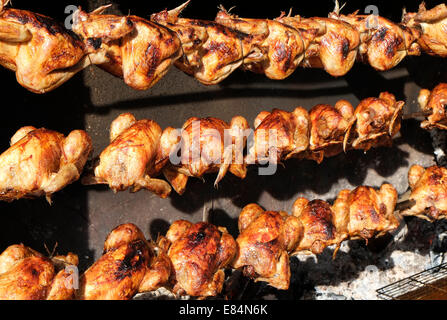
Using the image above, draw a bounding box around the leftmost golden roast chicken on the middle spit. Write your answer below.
[0,126,92,203]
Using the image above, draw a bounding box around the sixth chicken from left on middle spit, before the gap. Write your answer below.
[343,92,405,151]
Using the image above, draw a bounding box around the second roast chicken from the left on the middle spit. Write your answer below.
[82,113,171,198]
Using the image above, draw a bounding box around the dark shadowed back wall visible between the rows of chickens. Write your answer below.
[0,0,447,298]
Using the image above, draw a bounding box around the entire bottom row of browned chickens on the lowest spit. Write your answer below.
[0,165,447,300]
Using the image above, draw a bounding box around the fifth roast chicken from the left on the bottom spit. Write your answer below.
[292,198,348,256]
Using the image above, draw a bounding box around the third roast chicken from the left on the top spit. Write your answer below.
[151,1,251,85]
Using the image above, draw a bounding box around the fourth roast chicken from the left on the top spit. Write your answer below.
[215,7,316,80]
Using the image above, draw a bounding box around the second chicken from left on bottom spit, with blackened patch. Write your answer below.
[76,223,171,300]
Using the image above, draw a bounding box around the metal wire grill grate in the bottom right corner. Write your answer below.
[377,263,447,300]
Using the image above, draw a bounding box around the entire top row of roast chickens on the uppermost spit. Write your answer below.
[0,0,447,93]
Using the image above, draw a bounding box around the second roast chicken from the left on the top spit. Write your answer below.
[73,6,181,90]
